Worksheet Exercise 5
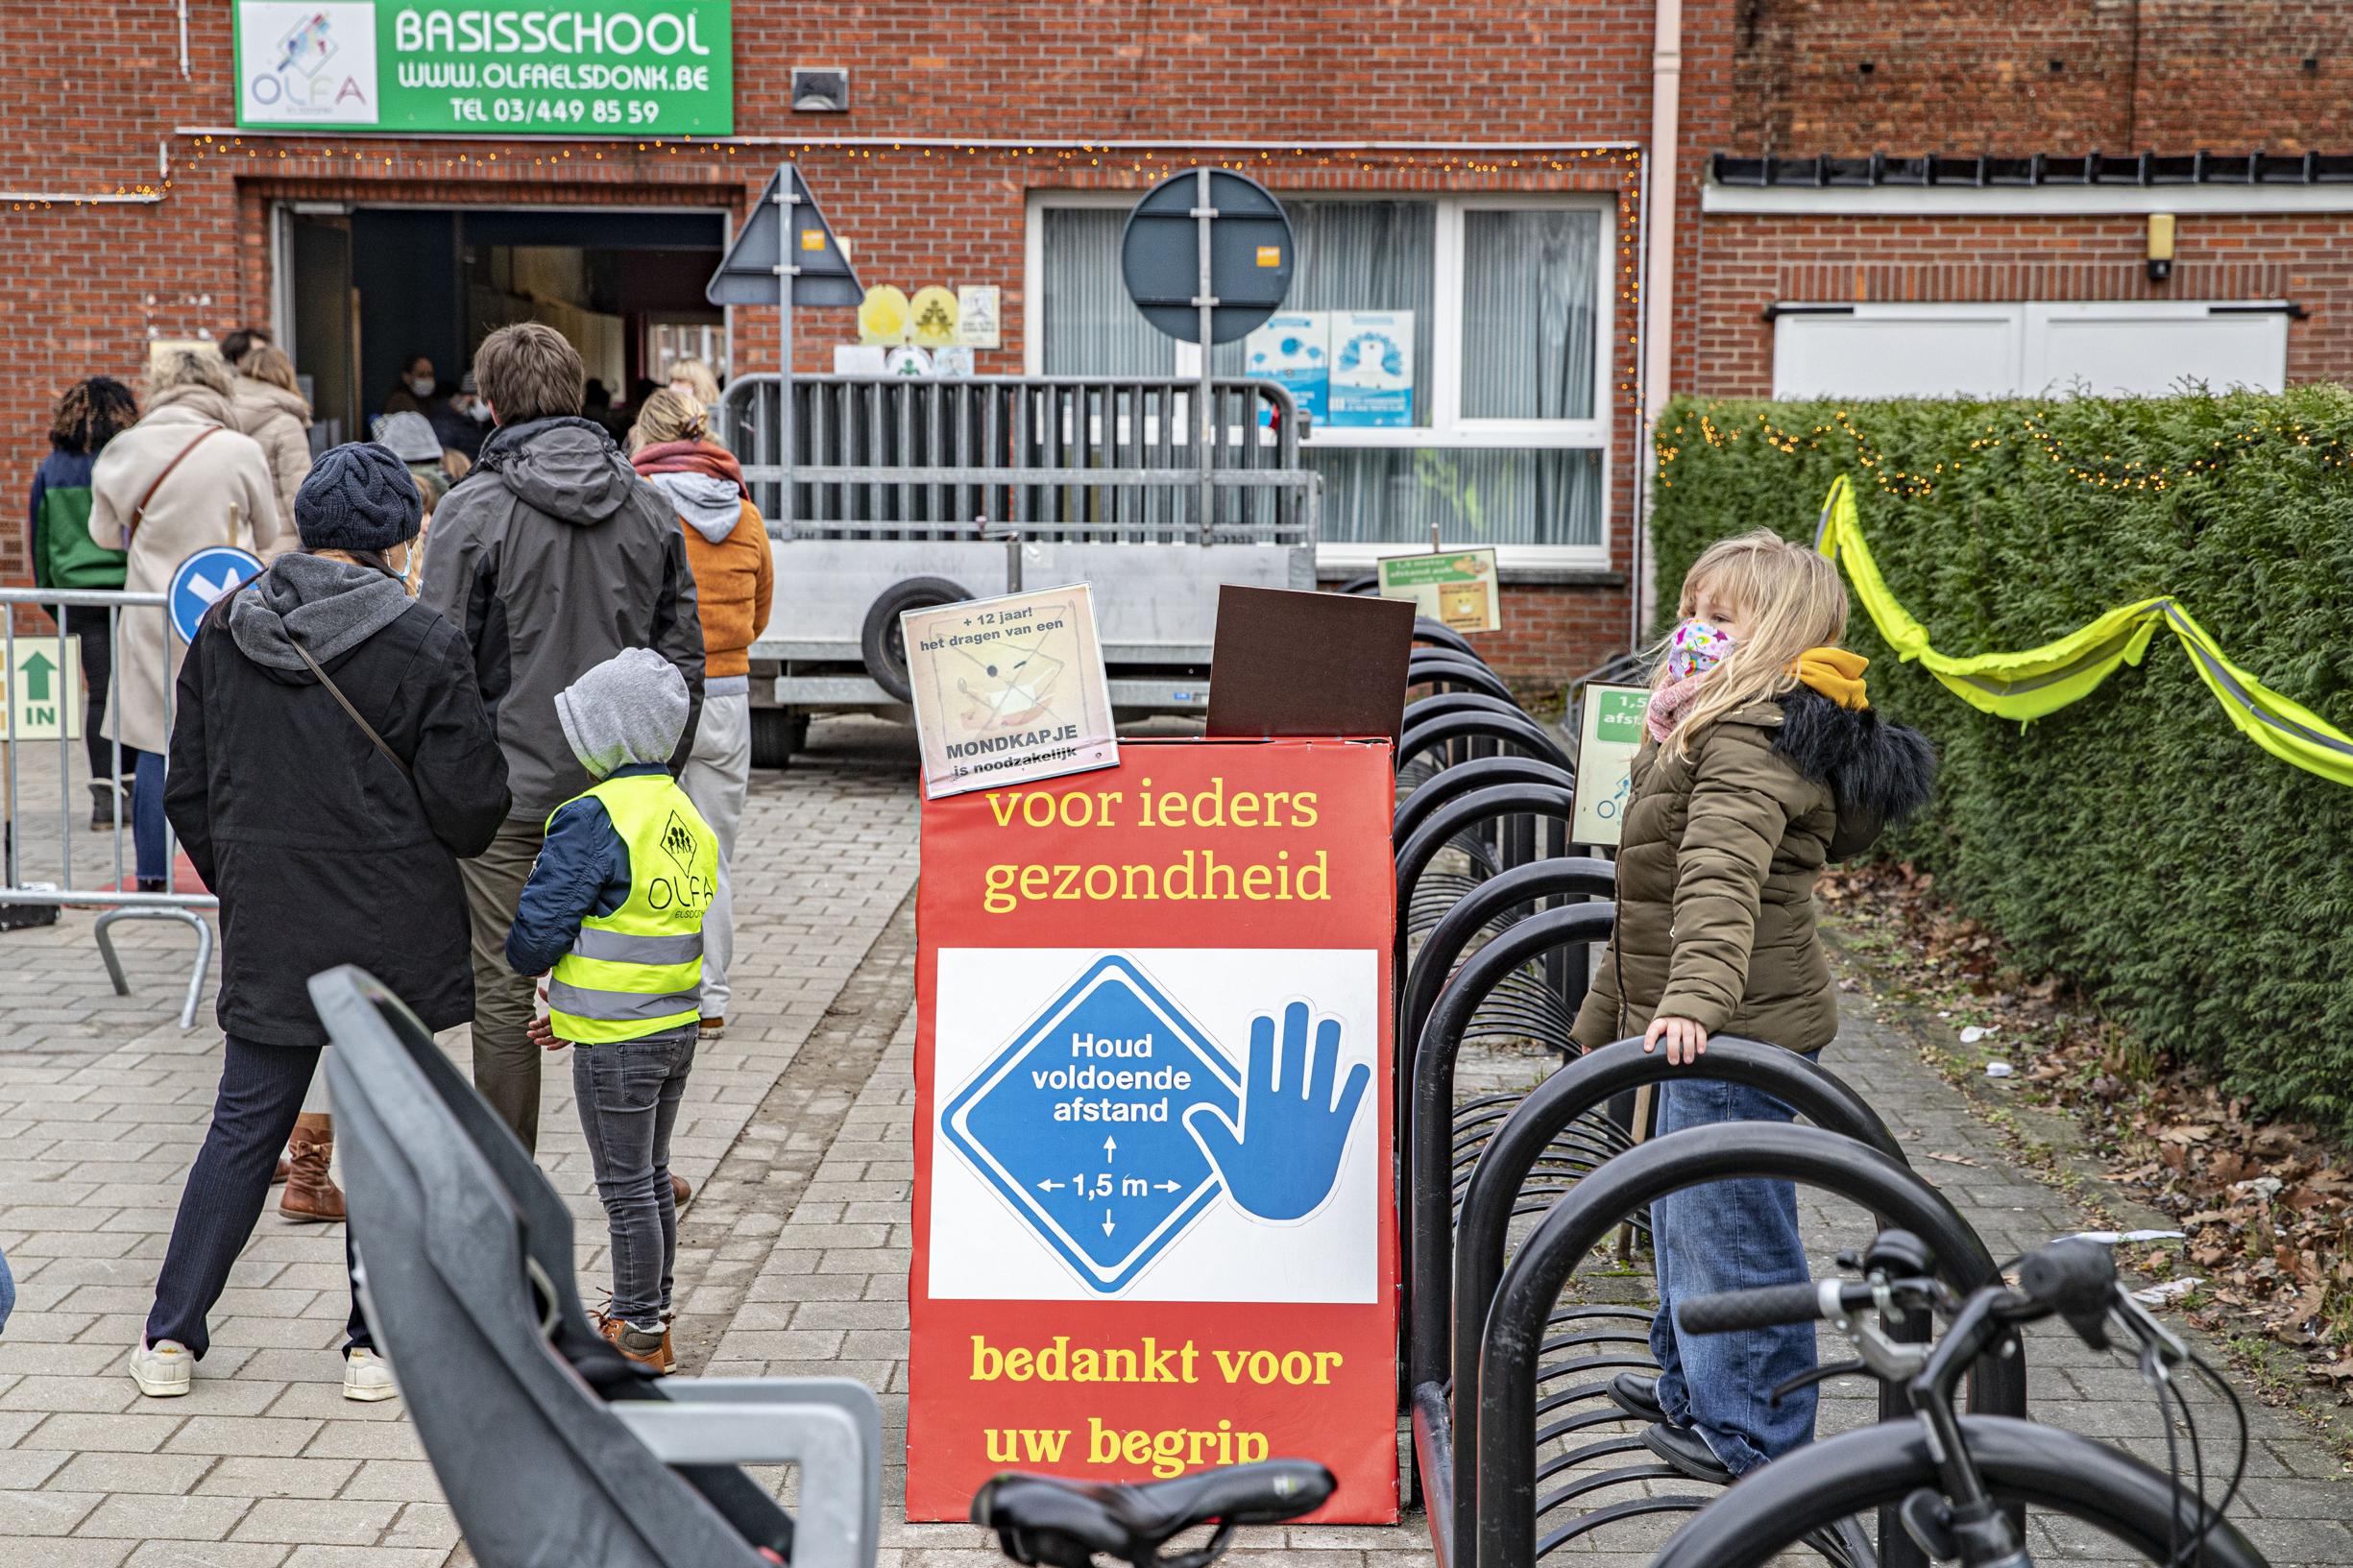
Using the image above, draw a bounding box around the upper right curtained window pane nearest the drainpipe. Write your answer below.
[1464,209,1602,419]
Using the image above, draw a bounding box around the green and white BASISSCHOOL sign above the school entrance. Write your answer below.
[235,0,734,136]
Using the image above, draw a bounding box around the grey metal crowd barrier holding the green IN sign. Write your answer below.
[0,588,221,1029]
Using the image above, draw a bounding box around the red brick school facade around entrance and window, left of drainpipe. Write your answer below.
[0,0,1665,672]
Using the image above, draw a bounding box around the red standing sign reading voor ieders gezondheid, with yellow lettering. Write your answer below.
[906,740,1397,1523]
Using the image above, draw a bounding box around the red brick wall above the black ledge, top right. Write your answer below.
[1722,0,2353,156]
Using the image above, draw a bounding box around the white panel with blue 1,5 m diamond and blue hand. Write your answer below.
[932,948,1379,1302]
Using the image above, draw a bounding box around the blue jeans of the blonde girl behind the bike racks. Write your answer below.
[1649,1058,1814,1477]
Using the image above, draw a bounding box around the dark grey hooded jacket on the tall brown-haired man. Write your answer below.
[417,419,704,828]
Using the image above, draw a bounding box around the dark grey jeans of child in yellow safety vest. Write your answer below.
[571,1023,699,1328]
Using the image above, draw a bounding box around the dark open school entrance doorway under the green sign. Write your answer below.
[276,200,727,446]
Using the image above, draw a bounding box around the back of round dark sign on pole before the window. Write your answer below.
[1120,169,1295,343]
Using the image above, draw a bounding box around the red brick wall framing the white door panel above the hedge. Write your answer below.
[1689,211,2353,398]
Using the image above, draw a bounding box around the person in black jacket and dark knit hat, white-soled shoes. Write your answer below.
[132,442,508,1399]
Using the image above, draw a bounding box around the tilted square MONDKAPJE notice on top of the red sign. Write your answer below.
[899,591,1120,799]
